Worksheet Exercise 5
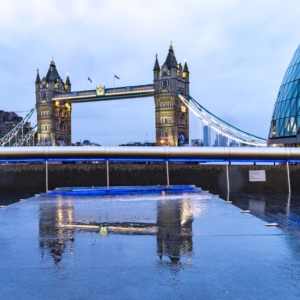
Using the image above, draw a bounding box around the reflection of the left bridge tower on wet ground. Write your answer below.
[39,199,75,264]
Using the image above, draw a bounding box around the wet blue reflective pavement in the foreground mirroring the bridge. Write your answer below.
[0,192,300,300]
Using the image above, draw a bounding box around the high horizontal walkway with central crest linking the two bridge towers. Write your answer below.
[52,84,154,103]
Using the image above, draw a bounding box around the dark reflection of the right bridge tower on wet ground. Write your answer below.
[157,200,193,262]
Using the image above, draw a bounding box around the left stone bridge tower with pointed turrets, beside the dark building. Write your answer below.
[35,59,72,146]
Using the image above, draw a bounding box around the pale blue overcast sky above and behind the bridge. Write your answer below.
[0,0,300,145]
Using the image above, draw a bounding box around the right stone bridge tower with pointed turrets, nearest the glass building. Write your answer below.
[153,43,190,146]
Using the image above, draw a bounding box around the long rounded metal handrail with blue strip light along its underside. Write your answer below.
[0,146,300,162]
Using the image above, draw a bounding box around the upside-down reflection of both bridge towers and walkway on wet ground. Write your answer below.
[39,197,193,264]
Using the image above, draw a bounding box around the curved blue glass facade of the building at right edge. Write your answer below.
[269,45,300,139]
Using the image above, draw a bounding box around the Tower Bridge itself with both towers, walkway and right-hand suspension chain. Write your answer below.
[4,45,266,146]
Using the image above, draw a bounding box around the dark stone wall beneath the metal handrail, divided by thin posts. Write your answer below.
[0,162,300,193]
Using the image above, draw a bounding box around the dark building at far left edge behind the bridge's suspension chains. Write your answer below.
[0,110,30,144]
